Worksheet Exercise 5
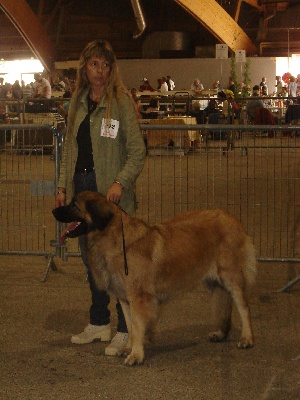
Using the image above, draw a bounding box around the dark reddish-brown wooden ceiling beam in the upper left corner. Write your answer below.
[0,0,58,72]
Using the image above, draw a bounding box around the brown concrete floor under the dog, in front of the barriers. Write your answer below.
[0,256,300,400]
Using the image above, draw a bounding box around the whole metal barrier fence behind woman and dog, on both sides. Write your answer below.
[0,125,300,278]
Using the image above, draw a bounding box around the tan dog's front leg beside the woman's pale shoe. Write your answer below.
[125,293,159,365]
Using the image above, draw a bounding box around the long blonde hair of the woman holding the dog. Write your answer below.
[73,40,131,118]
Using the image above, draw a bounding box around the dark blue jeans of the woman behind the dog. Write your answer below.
[74,172,127,332]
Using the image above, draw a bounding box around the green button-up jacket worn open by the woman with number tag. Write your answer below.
[58,89,146,214]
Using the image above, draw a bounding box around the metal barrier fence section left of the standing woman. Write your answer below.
[0,125,60,278]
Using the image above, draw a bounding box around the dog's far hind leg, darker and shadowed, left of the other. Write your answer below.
[209,286,232,342]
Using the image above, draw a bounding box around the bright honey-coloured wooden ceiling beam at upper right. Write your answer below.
[175,0,257,55]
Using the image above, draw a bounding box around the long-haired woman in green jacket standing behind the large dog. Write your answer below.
[55,40,146,355]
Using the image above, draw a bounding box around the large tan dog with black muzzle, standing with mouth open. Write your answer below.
[53,192,256,365]
